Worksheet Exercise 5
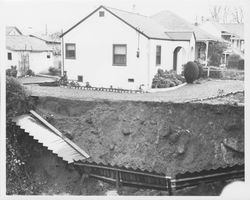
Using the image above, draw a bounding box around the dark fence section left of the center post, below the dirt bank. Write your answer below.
[74,161,172,195]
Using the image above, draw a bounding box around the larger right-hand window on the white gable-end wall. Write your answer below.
[113,44,127,66]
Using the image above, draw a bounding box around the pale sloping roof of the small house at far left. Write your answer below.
[6,35,52,51]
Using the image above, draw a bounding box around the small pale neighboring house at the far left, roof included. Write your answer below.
[6,27,53,76]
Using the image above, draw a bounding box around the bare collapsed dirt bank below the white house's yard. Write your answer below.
[35,97,244,175]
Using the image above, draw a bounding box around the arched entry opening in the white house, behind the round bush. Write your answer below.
[173,46,185,74]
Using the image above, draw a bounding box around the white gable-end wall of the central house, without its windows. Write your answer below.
[64,9,148,89]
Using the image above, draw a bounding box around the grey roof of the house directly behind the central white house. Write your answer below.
[151,10,221,41]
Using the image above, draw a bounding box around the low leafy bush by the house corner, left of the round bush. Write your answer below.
[152,69,185,88]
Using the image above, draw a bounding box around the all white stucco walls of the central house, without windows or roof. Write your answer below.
[63,9,195,89]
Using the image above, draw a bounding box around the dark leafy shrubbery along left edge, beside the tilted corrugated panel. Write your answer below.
[6,77,34,194]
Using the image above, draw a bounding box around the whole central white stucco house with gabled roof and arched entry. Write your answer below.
[61,6,196,89]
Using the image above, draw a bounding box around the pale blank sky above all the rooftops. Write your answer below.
[3,0,247,33]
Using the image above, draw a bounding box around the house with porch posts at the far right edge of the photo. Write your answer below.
[199,20,245,64]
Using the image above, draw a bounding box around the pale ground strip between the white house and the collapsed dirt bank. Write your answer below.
[25,80,244,102]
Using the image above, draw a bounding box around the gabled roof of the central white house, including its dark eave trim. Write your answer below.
[60,6,192,41]
